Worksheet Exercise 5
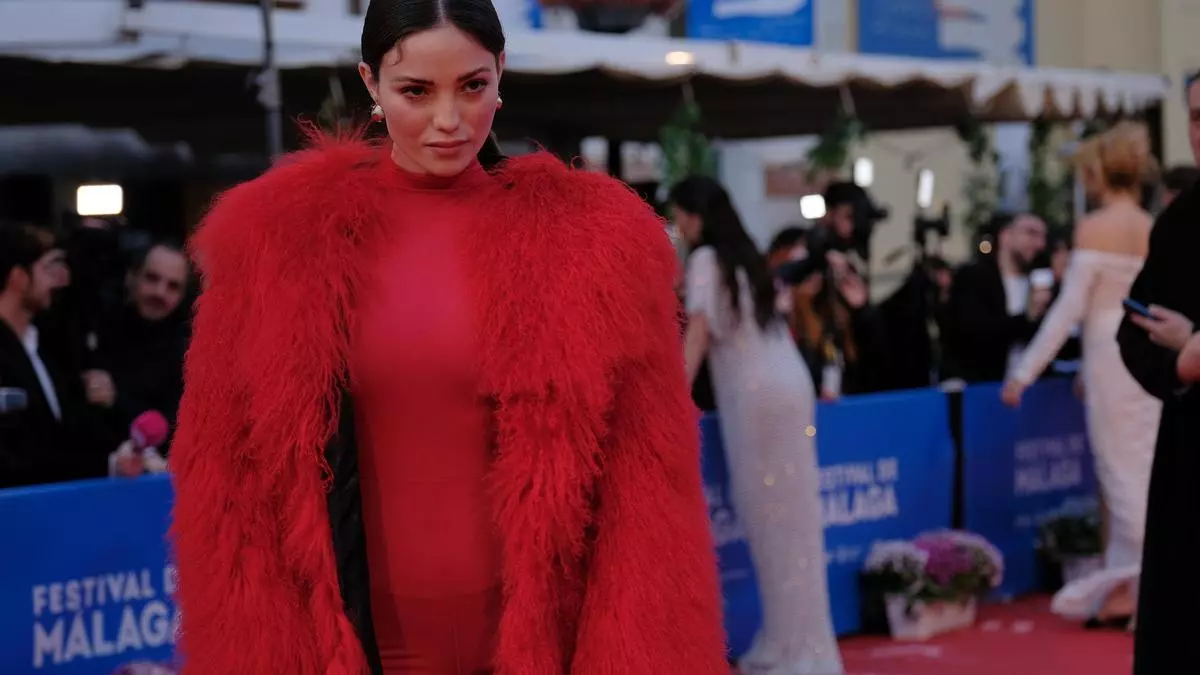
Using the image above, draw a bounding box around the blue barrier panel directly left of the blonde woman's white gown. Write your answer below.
[962,378,1096,596]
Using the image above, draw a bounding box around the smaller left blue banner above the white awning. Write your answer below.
[688,0,815,47]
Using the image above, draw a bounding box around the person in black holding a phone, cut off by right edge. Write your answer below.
[1117,72,1200,675]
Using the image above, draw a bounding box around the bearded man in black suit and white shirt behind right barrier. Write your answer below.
[946,214,1051,382]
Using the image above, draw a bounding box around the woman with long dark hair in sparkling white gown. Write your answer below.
[671,177,842,675]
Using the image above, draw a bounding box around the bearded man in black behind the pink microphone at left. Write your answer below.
[83,243,188,473]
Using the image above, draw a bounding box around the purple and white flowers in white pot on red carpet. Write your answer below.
[863,530,1004,640]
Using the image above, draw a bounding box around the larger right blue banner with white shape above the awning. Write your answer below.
[858,0,1034,66]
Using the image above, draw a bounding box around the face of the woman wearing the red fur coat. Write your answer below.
[359,24,504,178]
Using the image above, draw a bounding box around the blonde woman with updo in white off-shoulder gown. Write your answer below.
[1003,123,1162,621]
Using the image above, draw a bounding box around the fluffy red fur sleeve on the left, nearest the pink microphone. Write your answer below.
[170,174,364,675]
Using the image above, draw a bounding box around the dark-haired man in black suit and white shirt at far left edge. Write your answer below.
[0,225,106,488]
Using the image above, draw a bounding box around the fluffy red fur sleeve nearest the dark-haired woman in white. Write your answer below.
[571,186,730,675]
